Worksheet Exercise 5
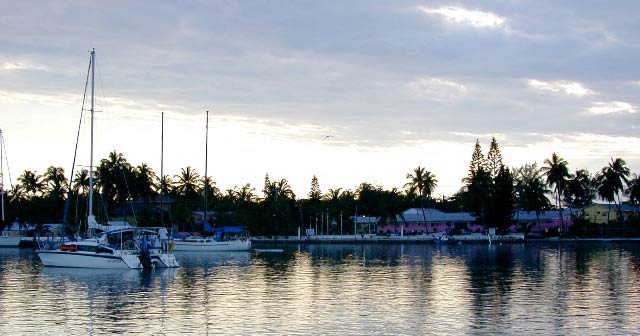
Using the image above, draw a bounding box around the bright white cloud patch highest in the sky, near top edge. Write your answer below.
[418,6,505,28]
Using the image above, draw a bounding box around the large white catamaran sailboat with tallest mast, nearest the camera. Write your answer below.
[36,49,178,269]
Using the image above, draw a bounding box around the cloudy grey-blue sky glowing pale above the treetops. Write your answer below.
[0,0,640,198]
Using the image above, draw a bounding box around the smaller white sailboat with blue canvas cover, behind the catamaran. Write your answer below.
[173,111,251,252]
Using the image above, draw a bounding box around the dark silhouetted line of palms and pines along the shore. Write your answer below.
[3,138,640,235]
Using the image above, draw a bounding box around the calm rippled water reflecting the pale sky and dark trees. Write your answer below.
[0,243,640,336]
